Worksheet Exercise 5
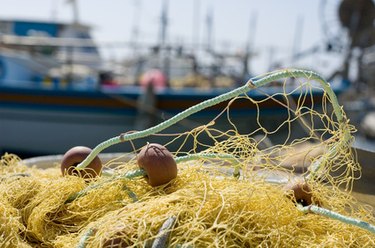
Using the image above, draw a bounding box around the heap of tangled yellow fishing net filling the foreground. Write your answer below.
[0,70,375,247]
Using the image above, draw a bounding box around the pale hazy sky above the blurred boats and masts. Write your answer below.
[0,0,348,74]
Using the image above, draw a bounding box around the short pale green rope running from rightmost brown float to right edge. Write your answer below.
[298,205,375,234]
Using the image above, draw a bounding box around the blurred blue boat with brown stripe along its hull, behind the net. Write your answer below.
[0,20,347,155]
